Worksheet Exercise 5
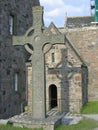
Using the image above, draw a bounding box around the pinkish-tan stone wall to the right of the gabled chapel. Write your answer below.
[60,25,98,101]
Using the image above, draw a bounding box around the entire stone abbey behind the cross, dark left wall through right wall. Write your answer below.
[0,0,98,118]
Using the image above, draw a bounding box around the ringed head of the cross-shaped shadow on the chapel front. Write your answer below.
[48,49,81,81]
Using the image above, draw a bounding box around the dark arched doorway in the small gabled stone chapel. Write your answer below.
[49,84,57,109]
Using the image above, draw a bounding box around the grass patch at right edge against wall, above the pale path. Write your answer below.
[81,101,98,114]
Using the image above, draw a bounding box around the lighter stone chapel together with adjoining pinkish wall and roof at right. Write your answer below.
[28,16,98,112]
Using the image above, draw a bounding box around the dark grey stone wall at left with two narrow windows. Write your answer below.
[0,0,39,118]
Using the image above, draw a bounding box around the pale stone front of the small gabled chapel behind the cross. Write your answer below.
[27,42,87,112]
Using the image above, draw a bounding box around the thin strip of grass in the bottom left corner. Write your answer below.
[0,124,43,130]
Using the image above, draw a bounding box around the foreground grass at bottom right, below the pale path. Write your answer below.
[55,118,98,130]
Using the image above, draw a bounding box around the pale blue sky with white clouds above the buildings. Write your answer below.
[40,0,91,26]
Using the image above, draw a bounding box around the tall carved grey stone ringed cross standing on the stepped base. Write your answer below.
[13,6,65,119]
